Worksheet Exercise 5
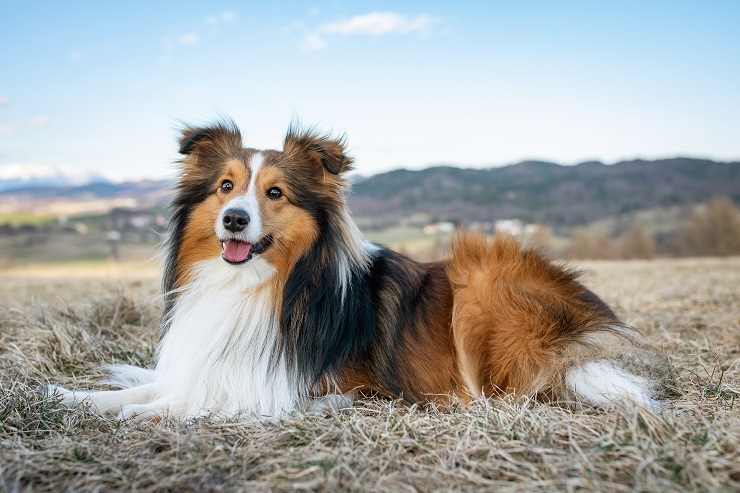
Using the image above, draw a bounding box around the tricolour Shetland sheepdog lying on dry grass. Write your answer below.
[54,121,672,419]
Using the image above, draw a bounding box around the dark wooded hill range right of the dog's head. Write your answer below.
[349,158,740,226]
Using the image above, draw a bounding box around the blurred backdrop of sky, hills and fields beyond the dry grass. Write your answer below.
[0,1,740,272]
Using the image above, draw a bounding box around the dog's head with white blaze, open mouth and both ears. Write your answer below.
[165,122,352,291]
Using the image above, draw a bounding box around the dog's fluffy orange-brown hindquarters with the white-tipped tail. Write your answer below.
[447,232,672,408]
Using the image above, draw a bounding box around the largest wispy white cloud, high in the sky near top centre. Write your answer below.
[301,12,440,51]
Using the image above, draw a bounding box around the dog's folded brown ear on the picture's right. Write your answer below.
[283,125,352,175]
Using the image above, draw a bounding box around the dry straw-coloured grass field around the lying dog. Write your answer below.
[0,258,740,492]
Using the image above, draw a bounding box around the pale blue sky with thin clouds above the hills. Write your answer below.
[0,0,740,178]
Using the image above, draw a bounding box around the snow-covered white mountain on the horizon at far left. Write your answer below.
[0,164,121,192]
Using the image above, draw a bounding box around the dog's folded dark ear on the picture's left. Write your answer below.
[180,120,242,166]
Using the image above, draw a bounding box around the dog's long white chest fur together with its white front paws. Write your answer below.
[53,257,307,418]
